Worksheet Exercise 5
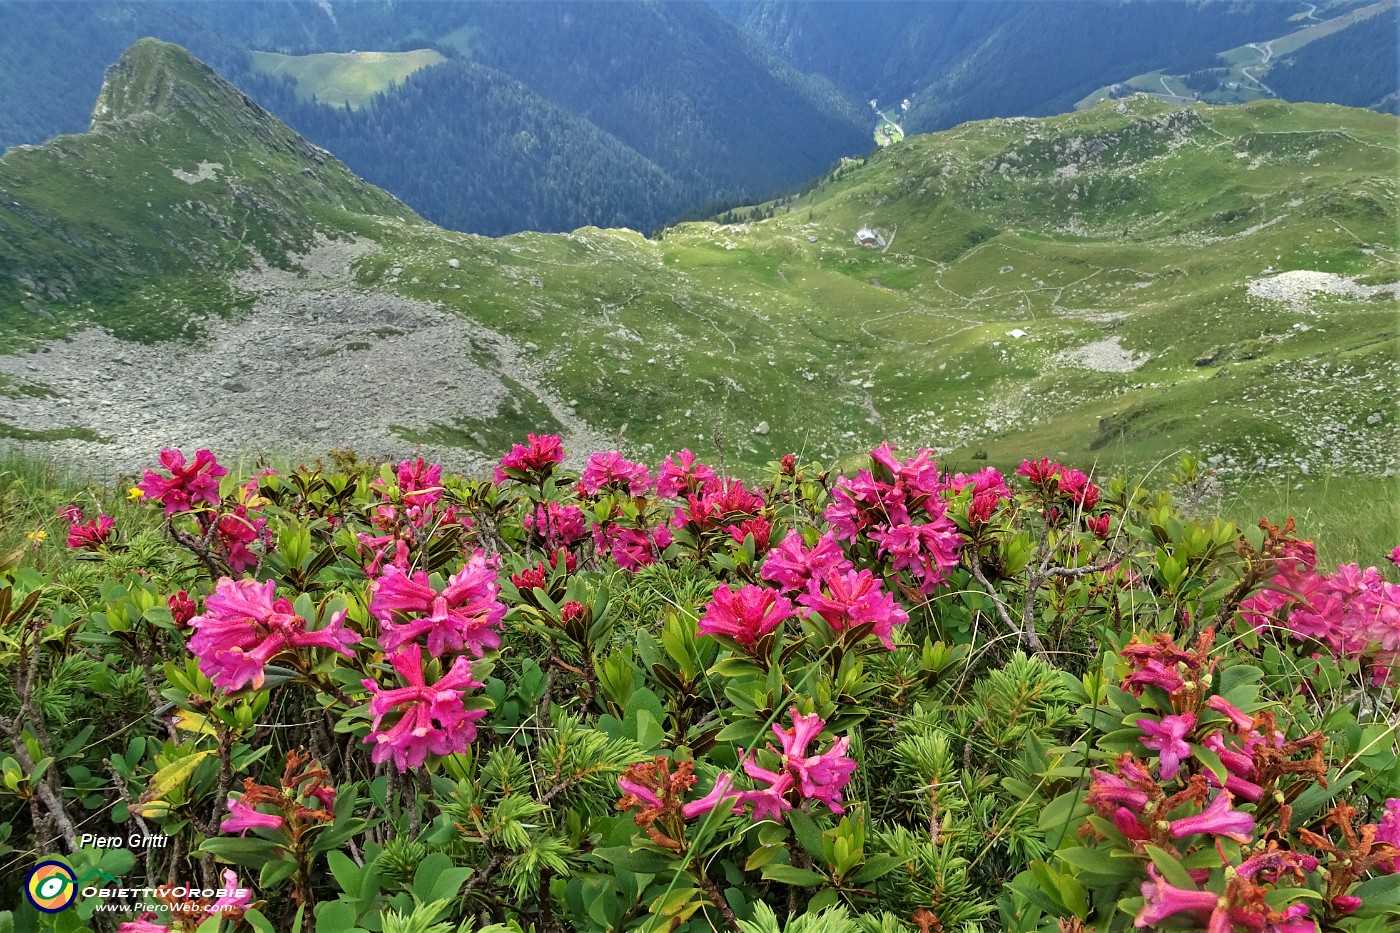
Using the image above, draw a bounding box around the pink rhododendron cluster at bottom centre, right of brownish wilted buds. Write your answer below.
[734,706,855,820]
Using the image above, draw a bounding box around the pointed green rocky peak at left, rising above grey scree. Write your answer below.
[0,39,413,341]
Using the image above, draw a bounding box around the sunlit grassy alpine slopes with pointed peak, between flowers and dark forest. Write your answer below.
[0,43,1400,493]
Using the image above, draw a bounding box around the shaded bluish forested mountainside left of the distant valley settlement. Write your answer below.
[0,0,869,235]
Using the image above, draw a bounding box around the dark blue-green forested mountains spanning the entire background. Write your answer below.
[0,0,1396,235]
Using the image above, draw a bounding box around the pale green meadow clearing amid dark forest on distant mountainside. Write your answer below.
[249,49,447,111]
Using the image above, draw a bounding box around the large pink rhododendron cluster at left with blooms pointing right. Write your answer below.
[189,577,360,691]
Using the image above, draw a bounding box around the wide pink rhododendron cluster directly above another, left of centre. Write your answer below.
[370,551,505,657]
